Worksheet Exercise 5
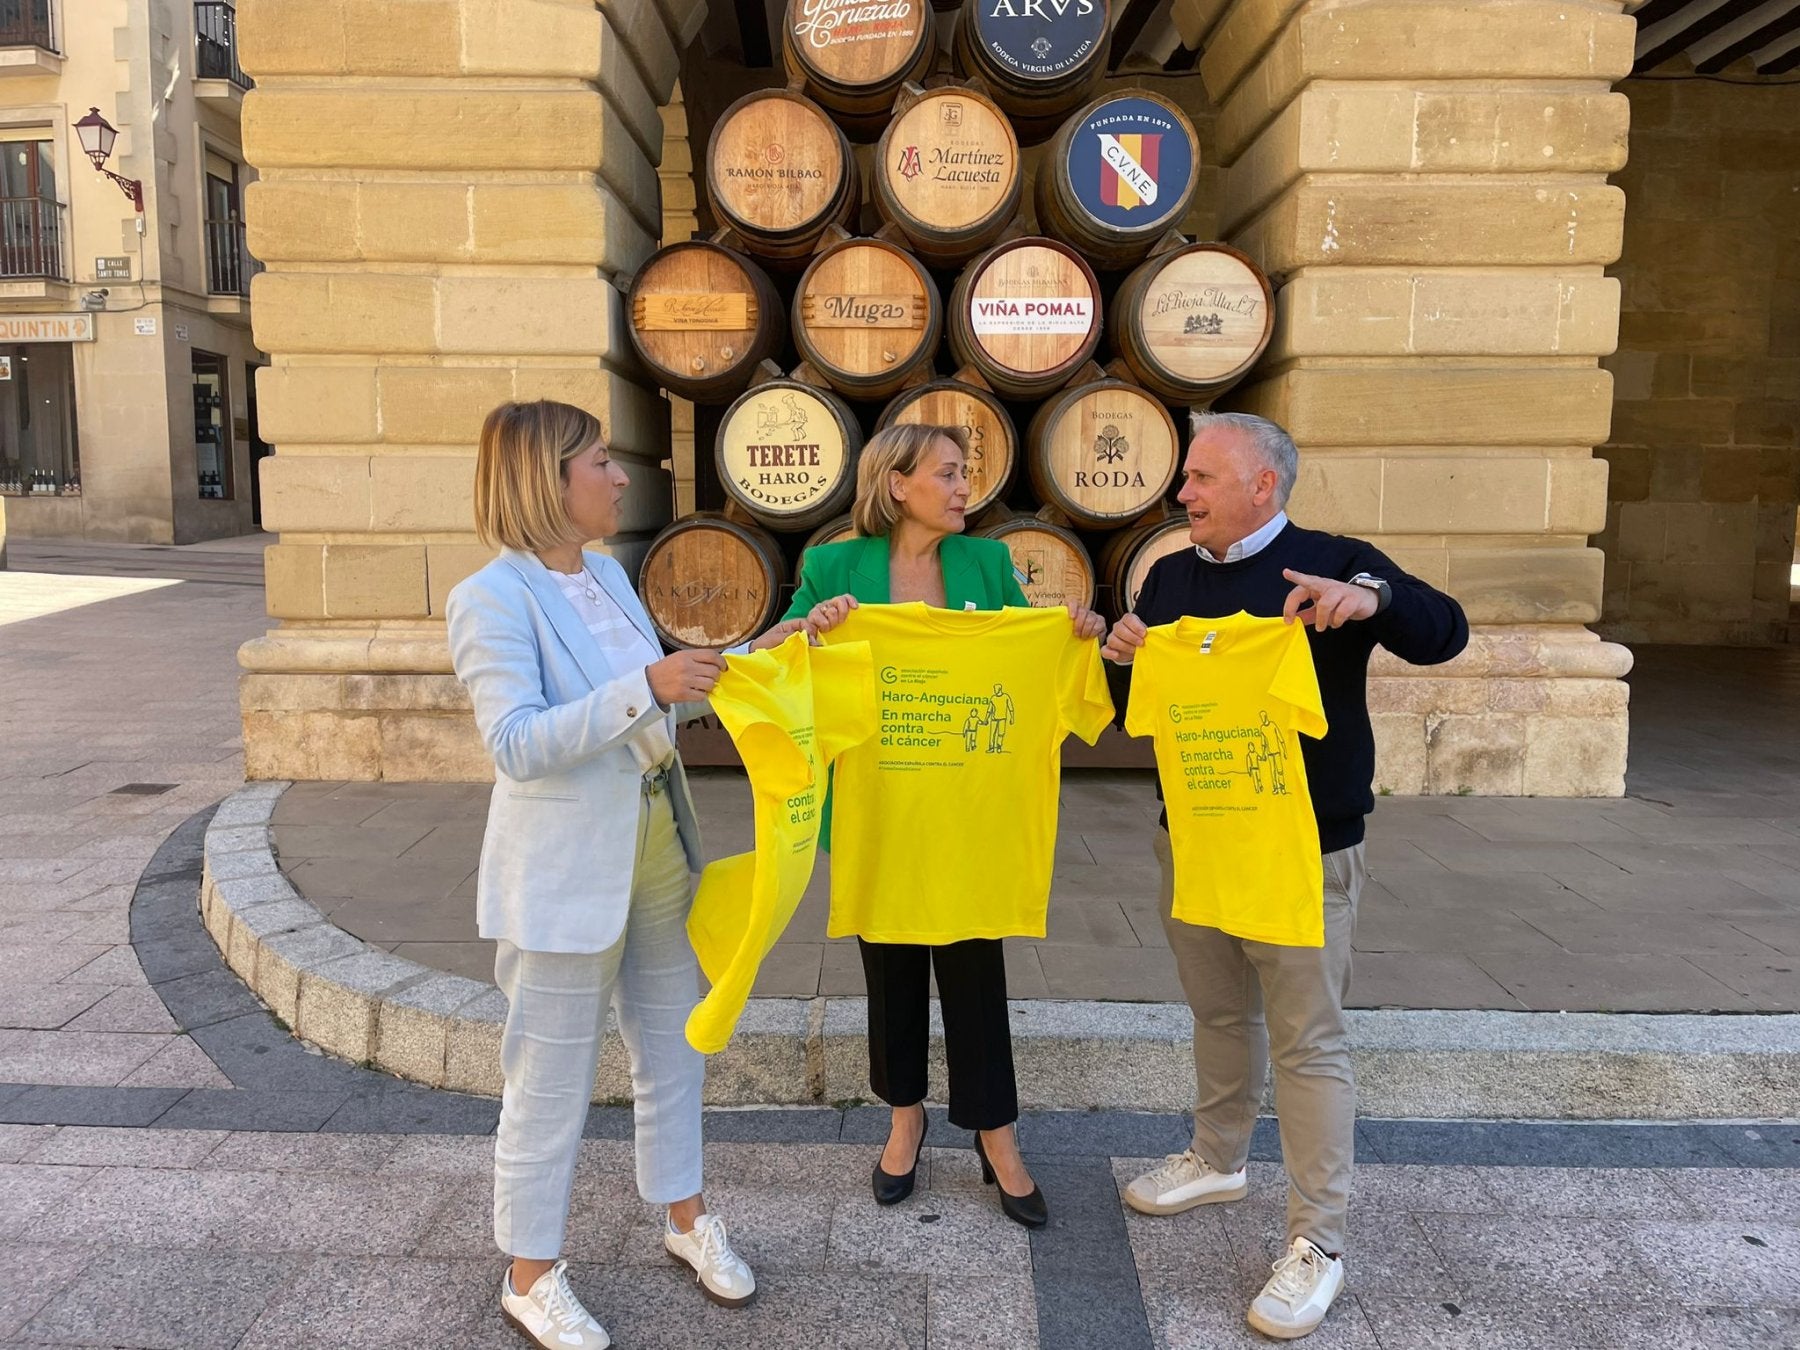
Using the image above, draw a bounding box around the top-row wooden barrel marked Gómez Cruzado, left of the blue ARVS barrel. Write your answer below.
[781,0,938,140]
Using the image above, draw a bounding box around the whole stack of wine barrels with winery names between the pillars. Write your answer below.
[626,0,1274,648]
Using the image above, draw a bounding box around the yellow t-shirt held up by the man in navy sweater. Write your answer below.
[1125,612,1325,947]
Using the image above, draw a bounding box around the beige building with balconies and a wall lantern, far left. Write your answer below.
[0,0,263,544]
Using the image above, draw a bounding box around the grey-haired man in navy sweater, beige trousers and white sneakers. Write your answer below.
[1102,412,1469,1339]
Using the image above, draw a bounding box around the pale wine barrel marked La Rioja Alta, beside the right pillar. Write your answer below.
[1109,243,1274,403]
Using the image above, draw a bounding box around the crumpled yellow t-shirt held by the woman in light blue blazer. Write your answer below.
[688,634,875,1055]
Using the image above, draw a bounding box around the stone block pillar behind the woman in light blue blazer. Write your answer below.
[238,0,706,779]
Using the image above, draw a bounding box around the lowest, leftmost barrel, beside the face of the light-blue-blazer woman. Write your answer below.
[637,511,787,648]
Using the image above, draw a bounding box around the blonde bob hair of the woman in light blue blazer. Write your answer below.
[475,400,605,553]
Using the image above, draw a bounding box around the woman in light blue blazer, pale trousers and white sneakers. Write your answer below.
[448,401,801,1350]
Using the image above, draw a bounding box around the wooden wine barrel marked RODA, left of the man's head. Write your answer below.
[1026,380,1181,529]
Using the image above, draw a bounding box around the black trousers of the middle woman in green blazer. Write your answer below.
[857,938,1019,1130]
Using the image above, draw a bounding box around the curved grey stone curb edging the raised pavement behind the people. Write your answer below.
[200,783,1800,1120]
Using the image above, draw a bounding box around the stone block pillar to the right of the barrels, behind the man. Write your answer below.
[1202,0,1634,796]
